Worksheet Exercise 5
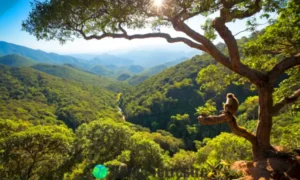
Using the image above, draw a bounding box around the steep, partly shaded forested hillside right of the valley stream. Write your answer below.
[121,53,216,146]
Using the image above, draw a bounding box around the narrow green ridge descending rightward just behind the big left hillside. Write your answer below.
[32,64,129,92]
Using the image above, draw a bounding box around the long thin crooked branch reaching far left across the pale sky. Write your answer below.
[76,28,206,51]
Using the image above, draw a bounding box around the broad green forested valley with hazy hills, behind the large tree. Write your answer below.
[0,38,299,177]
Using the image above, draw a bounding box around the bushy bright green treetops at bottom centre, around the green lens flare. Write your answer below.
[66,119,171,179]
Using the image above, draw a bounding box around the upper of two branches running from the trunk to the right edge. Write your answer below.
[268,53,300,83]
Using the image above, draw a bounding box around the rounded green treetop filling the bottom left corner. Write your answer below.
[0,119,75,179]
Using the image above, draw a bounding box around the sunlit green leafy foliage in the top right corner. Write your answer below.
[245,0,300,58]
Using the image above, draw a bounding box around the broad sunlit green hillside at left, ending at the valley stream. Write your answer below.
[0,65,121,129]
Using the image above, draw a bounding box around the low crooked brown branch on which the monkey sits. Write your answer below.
[198,113,256,145]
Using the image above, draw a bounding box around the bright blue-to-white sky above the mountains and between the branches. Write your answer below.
[0,0,268,54]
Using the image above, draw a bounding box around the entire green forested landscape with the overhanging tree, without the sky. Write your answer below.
[0,0,300,180]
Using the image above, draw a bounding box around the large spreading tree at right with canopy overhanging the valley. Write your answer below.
[23,0,300,160]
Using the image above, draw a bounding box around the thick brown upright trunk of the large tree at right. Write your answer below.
[252,84,274,160]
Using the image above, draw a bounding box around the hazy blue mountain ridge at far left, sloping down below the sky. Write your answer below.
[0,41,86,66]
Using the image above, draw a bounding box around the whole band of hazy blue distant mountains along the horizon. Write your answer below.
[0,41,195,81]
